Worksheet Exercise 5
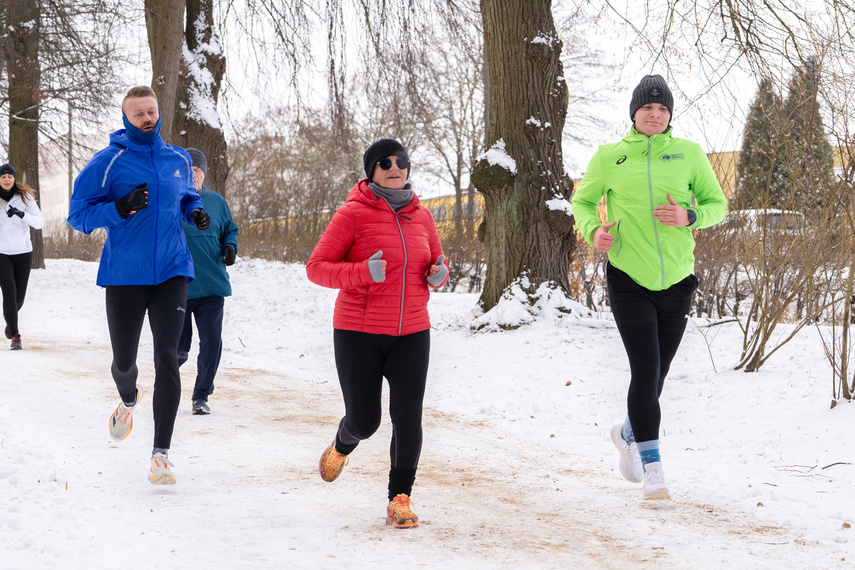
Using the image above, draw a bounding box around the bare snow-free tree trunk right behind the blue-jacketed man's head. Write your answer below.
[145,0,184,143]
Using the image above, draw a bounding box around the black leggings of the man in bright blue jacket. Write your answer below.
[107,277,187,449]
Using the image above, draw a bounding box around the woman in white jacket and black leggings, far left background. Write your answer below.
[0,160,44,350]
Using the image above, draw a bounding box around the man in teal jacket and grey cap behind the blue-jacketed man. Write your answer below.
[178,148,238,416]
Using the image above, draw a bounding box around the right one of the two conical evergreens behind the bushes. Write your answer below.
[782,58,834,213]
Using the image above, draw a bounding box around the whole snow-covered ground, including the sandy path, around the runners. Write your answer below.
[0,259,855,569]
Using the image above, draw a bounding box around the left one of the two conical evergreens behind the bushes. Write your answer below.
[733,78,785,210]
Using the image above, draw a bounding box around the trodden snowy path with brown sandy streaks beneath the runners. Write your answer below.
[5,339,848,569]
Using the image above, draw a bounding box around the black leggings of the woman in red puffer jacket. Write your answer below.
[333,329,430,500]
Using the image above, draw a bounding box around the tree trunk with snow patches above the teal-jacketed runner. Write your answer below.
[170,0,229,195]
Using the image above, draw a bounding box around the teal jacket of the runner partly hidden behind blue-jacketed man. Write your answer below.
[184,186,238,299]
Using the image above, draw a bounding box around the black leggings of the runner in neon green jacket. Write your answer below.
[606,264,698,442]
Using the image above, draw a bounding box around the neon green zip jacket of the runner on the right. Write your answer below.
[572,126,727,291]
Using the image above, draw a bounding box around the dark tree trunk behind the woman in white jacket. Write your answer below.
[5,0,45,269]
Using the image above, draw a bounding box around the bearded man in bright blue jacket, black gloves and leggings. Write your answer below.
[68,86,210,485]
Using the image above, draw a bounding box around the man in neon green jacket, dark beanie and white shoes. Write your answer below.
[573,75,727,499]
